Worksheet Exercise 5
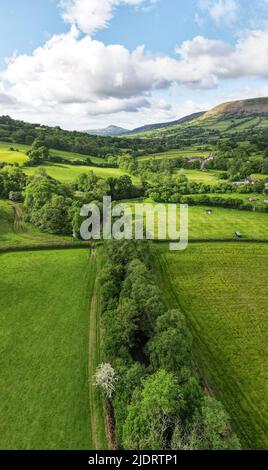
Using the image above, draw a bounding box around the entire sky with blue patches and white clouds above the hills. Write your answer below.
[0,0,268,128]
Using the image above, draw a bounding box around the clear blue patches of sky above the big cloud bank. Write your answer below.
[0,0,268,62]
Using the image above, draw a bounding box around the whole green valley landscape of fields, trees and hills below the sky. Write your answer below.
[0,98,268,450]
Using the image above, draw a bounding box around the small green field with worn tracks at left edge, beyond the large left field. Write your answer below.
[0,199,75,250]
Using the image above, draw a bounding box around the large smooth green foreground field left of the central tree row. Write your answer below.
[0,250,107,450]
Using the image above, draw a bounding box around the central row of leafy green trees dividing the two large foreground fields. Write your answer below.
[97,241,240,450]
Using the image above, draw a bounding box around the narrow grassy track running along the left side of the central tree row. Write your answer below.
[88,249,108,450]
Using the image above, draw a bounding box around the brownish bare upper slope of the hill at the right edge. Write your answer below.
[202,98,268,119]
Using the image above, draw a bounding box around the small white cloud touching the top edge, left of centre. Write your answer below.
[60,0,145,35]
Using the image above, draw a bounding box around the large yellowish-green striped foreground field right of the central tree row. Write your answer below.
[154,243,268,449]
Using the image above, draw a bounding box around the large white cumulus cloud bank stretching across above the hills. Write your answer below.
[0,26,268,126]
